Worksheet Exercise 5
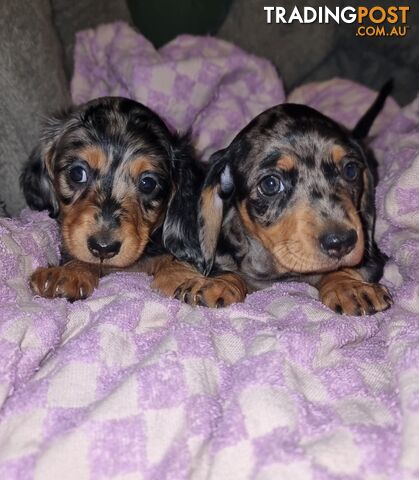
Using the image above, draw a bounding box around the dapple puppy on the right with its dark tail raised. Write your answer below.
[171,84,392,315]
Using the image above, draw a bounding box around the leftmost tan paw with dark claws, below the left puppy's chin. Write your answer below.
[30,265,99,302]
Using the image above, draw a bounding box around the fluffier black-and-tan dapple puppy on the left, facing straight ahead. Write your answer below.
[21,97,207,300]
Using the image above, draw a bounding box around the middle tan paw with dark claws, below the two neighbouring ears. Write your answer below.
[174,275,247,308]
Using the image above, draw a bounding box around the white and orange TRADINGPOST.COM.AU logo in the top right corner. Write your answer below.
[263,5,410,37]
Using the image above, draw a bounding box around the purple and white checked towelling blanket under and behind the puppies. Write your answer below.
[0,23,419,480]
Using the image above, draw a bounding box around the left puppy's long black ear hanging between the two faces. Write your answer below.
[162,135,205,272]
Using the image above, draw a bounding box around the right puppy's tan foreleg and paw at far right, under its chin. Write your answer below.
[317,268,393,315]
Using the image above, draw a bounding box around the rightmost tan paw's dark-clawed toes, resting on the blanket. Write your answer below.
[320,280,393,315]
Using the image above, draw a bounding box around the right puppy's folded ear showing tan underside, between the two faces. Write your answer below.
[198,149,234,275]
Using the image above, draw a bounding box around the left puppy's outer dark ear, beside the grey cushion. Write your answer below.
[20,111,70,218]
